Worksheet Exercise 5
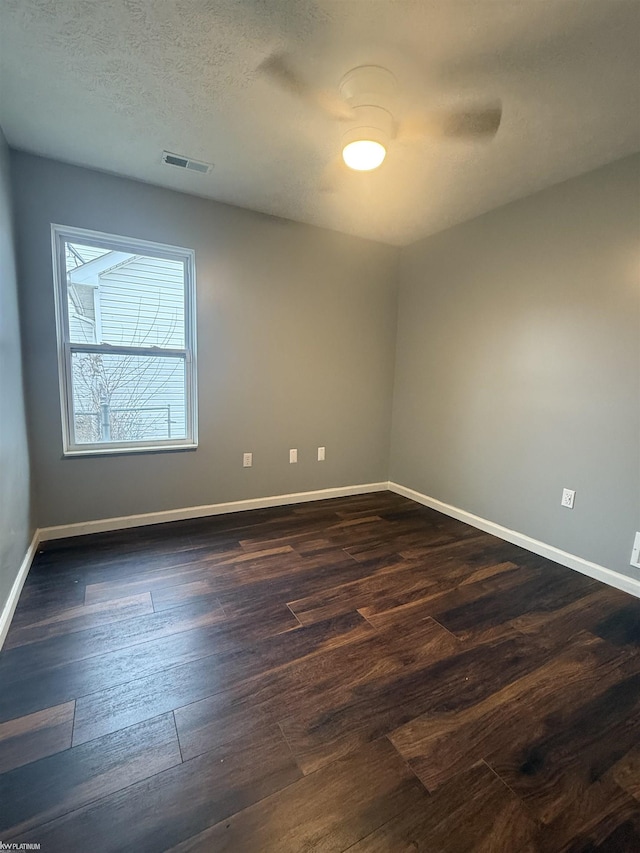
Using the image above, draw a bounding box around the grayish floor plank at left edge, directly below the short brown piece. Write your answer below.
[0,714,181,849]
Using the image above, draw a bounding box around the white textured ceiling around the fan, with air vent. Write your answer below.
[0,0,640,244]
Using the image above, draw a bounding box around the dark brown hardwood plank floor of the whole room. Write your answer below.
[0,492,640,853]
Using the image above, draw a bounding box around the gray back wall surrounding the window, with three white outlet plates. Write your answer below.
[12,152,398,527]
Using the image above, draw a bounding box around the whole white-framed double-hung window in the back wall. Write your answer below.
[52,225,197,456]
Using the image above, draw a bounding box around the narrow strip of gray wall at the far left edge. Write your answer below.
[0,130,33,611]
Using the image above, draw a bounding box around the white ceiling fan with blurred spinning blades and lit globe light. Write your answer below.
[257,53,502,178]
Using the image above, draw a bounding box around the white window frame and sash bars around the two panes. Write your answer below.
[51,223,198,456]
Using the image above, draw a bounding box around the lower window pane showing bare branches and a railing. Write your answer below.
[71,352,187,444]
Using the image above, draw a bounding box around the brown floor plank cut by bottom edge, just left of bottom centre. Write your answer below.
[165,740,427,853]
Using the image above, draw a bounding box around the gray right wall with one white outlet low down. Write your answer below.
[390,156,640,577]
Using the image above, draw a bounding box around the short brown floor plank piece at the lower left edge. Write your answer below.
[0,702,75,774]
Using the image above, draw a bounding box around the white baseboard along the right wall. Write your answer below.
[389,482,640,598]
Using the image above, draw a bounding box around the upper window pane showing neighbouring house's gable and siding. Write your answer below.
[65,241,185,349]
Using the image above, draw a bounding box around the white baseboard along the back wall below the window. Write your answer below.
[39,481,389,542]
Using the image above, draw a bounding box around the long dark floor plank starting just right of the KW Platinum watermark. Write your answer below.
[16,727,301,853]
